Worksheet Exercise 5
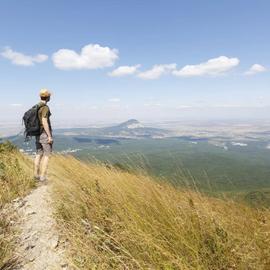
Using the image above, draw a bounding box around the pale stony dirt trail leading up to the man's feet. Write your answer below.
[15,185,71,270]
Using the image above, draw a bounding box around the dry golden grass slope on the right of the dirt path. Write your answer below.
[51,156,270,270]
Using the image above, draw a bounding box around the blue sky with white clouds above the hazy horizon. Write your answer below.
[0,0,270,124]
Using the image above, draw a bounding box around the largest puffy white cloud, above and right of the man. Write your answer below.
[52,44,118,70]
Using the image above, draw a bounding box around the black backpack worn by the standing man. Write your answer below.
[23,104,45,140]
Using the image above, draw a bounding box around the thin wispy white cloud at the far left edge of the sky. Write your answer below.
[1,47,48,66]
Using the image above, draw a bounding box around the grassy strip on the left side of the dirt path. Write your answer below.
[0,143,34,269]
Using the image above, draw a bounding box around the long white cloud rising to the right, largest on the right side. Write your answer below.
[172,56,240,77]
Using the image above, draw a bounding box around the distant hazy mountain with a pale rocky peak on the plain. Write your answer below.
[54,119,171,138]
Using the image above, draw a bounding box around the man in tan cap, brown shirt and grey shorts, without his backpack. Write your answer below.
[35,89,53,181]
